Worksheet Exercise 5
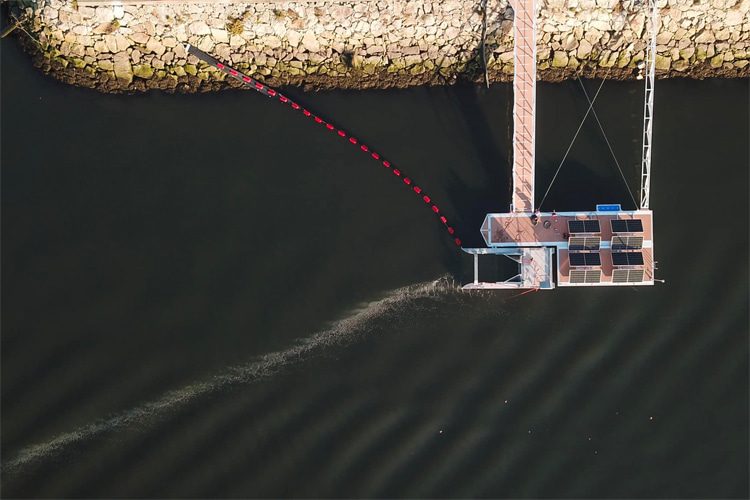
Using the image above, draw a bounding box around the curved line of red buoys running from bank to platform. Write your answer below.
[185,44,461,246]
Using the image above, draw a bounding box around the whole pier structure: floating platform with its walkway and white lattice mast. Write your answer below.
[463,0,658,290]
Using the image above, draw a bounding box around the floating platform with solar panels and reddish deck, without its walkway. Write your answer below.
[464,206,656,290]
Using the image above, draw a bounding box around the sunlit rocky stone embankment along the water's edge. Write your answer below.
[7,0,750,92]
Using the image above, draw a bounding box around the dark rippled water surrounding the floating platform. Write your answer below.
[0,42,750,498]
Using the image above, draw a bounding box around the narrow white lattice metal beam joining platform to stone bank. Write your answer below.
[641,0,659,210]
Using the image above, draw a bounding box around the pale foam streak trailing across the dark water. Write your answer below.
[2,275,458,473]
